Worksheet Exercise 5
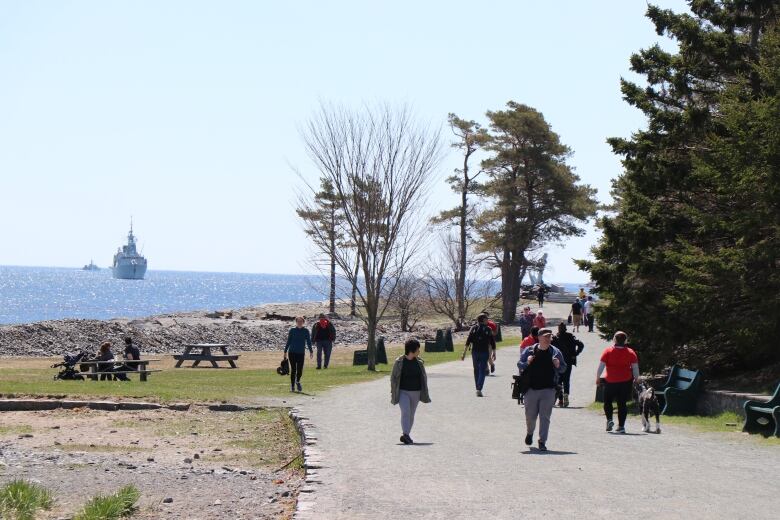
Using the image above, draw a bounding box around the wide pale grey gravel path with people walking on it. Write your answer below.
[304,333,780,520]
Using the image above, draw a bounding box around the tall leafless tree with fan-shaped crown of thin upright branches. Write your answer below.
[302,105,441,370]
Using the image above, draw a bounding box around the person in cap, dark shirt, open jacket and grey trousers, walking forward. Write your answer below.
[517,328,566,451]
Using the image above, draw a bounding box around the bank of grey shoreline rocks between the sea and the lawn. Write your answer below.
[0,302,460,357]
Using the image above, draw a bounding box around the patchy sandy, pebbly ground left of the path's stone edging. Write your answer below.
[0,407,302,519]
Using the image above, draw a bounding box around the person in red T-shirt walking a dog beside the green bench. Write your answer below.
[596,331,639,433]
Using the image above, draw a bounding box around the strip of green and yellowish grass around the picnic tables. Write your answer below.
[0,338,518,402]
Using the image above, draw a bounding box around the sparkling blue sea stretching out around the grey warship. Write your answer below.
[0,266,327,324]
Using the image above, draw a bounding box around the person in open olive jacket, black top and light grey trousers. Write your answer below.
[390,339,431,444]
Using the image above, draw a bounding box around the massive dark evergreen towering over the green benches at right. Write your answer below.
[581,0,778,369]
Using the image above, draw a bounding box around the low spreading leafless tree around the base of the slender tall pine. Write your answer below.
[425,234,498,330]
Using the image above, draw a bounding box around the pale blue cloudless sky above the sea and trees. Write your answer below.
[0,0,687,282]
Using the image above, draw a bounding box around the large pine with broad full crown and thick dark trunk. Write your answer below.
[475,101,596,322]
